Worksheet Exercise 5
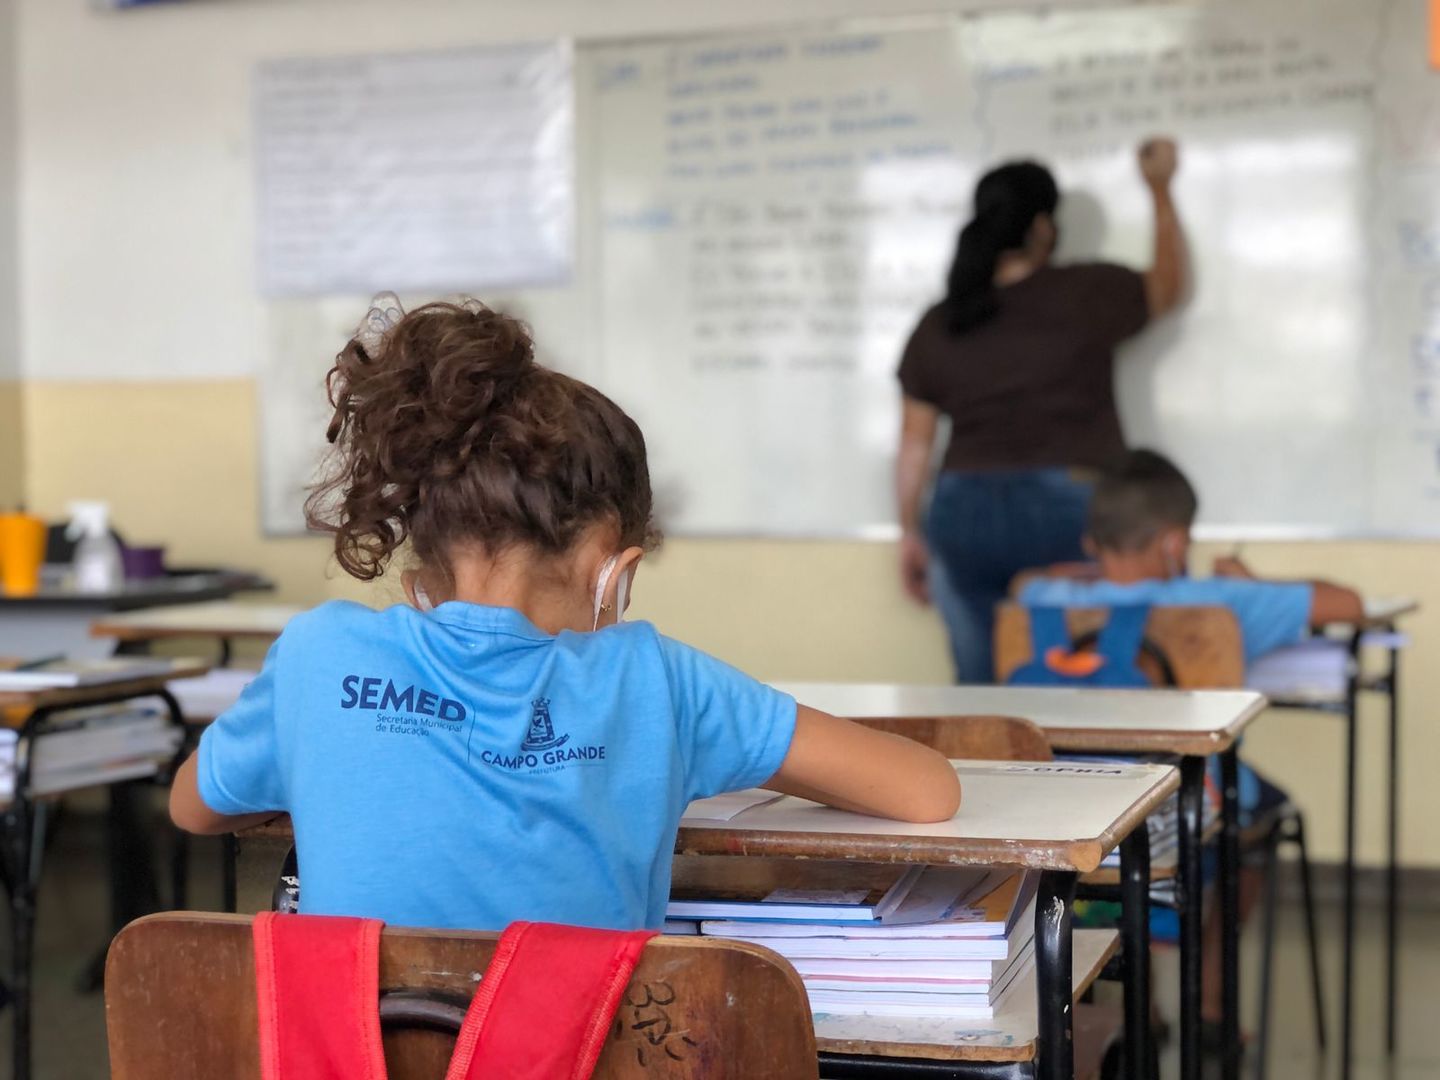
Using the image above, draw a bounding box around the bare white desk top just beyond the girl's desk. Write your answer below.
[778,683,1266,755]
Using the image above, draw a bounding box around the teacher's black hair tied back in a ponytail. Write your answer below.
[945,161,1060,333]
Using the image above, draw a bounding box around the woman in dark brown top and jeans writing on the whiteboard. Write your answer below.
[896,140,1187,683]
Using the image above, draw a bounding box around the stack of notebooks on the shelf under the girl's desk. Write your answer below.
[668,858,1038,1020]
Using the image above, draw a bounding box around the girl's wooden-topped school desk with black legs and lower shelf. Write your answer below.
[679,762,1179,1080]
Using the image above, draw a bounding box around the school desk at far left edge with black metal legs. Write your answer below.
[0,660,209,1080]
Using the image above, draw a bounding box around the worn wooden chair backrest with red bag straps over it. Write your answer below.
[105,912,818,1080]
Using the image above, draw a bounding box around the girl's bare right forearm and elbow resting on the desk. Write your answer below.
[765,706,960,822]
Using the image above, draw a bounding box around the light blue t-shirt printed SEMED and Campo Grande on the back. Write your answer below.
[197,602,795,930]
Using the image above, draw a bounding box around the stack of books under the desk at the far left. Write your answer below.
[0,706,183,801]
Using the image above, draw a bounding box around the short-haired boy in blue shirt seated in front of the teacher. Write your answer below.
[1018,449,1364,664]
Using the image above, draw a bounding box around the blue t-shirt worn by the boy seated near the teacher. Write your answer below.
[1020,577,1315,664]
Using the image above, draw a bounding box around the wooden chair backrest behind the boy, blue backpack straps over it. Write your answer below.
[995,603,1246,690]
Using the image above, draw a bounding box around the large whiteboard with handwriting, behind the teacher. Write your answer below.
[266,0,1440,537]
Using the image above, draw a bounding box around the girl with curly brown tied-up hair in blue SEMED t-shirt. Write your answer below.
[170,297,960,929]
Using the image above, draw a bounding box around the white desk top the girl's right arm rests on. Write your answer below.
[675,762,1179,873]
